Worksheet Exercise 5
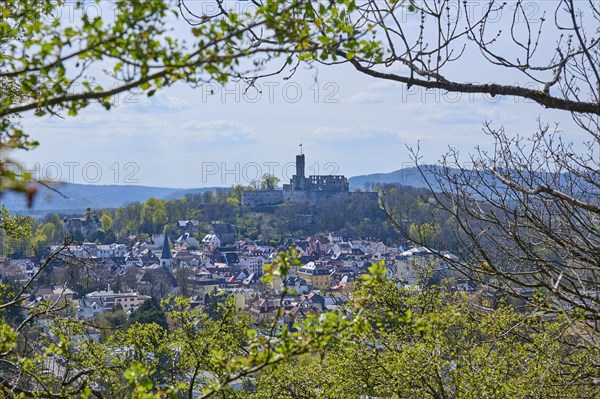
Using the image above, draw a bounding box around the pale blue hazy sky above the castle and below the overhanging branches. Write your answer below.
[12,2,592,188]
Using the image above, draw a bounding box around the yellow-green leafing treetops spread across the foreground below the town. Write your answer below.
[0,250,600,398]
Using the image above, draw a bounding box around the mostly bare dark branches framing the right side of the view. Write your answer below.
[314,0,600,328]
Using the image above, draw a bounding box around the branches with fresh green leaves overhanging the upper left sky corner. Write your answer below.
[0,0,370,197]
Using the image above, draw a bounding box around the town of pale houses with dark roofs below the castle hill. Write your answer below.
[0,212,464,332]
